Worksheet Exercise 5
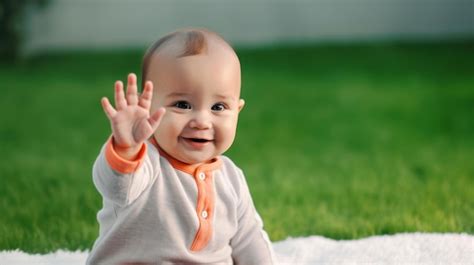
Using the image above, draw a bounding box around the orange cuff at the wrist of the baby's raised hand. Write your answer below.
[105,136,147,174]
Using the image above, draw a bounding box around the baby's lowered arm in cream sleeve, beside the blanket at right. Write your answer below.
[230,170,276,265]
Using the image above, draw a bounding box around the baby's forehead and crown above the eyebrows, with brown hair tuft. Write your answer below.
[142,30,240,94]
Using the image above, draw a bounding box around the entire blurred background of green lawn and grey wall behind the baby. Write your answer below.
[0,0,474,253]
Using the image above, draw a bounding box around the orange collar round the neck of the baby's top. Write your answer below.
[150,136,222,176]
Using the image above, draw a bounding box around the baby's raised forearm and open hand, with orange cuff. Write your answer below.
[93,74,165,206]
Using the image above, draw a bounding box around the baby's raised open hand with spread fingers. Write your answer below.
[101,73,166,160]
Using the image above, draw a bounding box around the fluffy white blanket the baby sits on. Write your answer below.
[0,233,474,265]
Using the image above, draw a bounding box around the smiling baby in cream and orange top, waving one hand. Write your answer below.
[87,29,275,265]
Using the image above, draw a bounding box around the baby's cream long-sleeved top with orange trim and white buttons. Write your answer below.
[87,139,275,265]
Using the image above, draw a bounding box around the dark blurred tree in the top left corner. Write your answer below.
[0,0,49,61]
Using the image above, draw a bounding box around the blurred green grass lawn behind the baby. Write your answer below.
[0,42,474,253]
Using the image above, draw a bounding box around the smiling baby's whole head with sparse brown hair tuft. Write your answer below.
[142,29,244,164]
